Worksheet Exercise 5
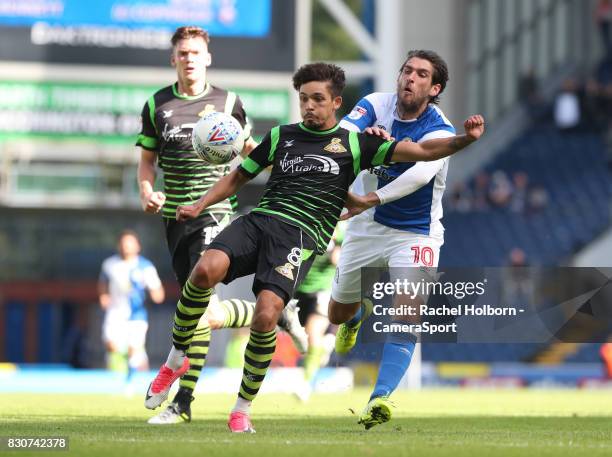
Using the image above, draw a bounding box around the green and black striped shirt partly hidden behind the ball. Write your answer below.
[136,83,249,219]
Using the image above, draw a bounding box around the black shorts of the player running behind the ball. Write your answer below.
[163,214,228,288]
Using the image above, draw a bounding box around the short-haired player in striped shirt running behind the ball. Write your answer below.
[137,27,303,424]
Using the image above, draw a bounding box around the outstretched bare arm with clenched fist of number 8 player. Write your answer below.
[391,114,484,162]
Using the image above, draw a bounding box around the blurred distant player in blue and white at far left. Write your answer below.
[98,230,165,382]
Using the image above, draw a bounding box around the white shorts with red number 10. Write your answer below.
[331,213,444,303]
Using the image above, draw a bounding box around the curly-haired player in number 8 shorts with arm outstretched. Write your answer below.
[146,63,484,432]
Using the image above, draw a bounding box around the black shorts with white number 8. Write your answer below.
[208,213,316,304]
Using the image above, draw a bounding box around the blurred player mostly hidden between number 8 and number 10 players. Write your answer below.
[295,222,346,402]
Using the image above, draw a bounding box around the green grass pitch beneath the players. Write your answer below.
[0,386,612,457]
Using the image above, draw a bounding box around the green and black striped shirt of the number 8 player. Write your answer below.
[239,123,395,254]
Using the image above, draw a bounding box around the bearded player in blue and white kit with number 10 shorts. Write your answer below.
[329,50,484,429]
